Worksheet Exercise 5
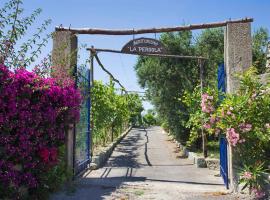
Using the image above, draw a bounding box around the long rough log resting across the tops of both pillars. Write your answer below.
[55,18,253,35]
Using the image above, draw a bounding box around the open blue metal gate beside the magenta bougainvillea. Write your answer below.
[74,69,91,175]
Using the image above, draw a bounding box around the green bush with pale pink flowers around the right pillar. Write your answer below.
[184,68,270,198]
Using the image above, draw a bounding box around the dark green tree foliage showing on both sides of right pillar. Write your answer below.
[135,28,268,145]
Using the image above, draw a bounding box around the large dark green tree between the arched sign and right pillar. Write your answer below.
[135,29,223,142]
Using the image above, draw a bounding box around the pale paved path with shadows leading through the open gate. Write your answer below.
[52,127,234,200]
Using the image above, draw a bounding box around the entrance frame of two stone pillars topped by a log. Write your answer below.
[52,18,253,190]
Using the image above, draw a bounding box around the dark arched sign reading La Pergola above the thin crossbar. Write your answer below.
[121,38,166,54]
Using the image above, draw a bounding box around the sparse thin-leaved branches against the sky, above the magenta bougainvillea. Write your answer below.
[0,0,51,69]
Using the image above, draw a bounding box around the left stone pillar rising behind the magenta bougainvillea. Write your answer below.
[51,31,78,170]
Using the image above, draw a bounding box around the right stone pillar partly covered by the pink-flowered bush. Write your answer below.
[224,22,252,191]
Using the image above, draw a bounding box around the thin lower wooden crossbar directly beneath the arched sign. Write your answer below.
[86,48,207,60]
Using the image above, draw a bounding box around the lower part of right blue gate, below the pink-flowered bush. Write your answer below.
[219,137,229,189]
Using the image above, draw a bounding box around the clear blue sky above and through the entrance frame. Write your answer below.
[0,0,270,108]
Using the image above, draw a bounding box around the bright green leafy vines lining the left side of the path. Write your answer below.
[91,81,143,146]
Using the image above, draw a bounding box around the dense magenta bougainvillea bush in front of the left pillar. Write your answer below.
[0,65,81,198]
